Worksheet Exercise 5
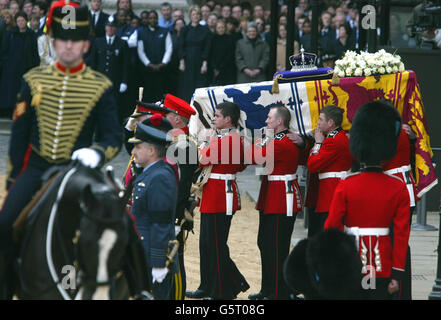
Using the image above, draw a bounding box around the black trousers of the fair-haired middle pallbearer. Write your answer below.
[257,211,296,300]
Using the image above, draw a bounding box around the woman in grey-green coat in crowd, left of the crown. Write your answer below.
[236,22,269,83]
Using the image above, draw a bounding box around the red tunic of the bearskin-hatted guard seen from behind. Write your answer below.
[324,172,410,278]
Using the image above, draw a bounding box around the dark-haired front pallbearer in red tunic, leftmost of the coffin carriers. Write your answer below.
[186,102,249,300]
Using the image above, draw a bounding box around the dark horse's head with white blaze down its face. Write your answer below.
[70,165,128,299]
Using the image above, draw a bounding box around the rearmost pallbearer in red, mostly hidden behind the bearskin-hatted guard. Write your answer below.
[383,124,418,300]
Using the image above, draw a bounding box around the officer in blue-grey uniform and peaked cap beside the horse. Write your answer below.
[129,122,179,300]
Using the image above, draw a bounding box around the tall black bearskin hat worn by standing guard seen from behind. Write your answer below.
[349,100,401,165]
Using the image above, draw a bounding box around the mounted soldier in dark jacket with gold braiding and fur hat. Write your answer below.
[0,0,147,298]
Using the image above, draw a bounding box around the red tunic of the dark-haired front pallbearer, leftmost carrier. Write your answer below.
[200,131,246,213]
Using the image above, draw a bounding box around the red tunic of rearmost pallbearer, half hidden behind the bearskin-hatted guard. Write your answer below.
[383,129,418,206]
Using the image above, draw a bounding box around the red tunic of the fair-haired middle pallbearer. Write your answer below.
[247,130,302,214]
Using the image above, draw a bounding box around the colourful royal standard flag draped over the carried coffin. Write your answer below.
[190,71,438,197]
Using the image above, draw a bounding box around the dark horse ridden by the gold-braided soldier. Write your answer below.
[15,162,133,300]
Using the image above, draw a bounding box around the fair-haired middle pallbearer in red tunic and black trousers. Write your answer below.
[247,106,302,300]
